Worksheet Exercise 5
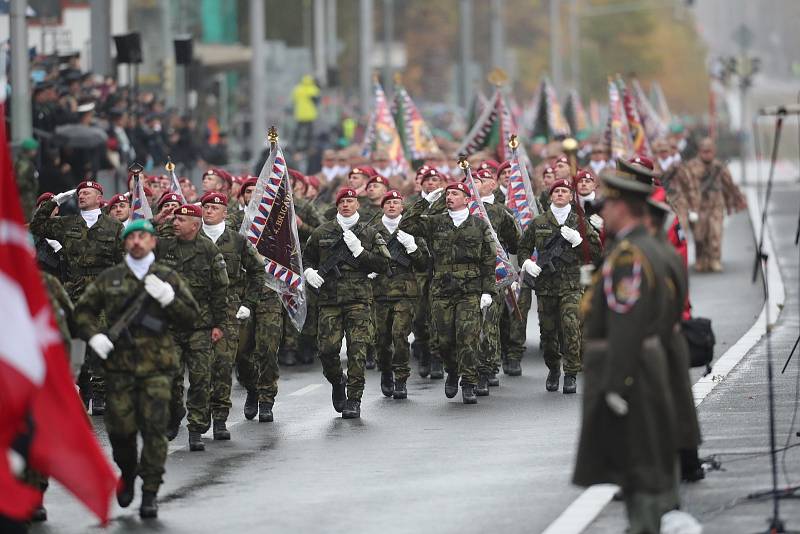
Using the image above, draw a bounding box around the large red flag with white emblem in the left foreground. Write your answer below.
[0,102,117,524]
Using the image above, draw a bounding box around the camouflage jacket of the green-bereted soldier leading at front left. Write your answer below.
[75,262,200,376]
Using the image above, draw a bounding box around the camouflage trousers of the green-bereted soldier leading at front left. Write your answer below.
[105,372,172,492]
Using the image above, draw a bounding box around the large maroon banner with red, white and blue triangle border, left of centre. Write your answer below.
[239,142,307,332]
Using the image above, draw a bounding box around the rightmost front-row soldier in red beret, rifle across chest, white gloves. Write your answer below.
[518,180,601,394]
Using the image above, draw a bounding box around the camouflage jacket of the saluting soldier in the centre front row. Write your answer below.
[400,198,497,298]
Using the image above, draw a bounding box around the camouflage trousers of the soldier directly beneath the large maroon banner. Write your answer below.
[236,297,282,405]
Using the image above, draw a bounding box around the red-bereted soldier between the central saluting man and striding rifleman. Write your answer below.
[370,190,430,399]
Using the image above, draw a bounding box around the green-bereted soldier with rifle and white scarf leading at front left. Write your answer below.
[75,219,199,518]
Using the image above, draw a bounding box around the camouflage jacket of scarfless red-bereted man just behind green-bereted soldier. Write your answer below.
[156,233,229,330]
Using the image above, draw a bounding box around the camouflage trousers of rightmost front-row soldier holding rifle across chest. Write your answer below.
[536,290,581,374]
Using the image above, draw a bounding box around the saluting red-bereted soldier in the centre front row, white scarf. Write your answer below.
[400,183,497,404]
